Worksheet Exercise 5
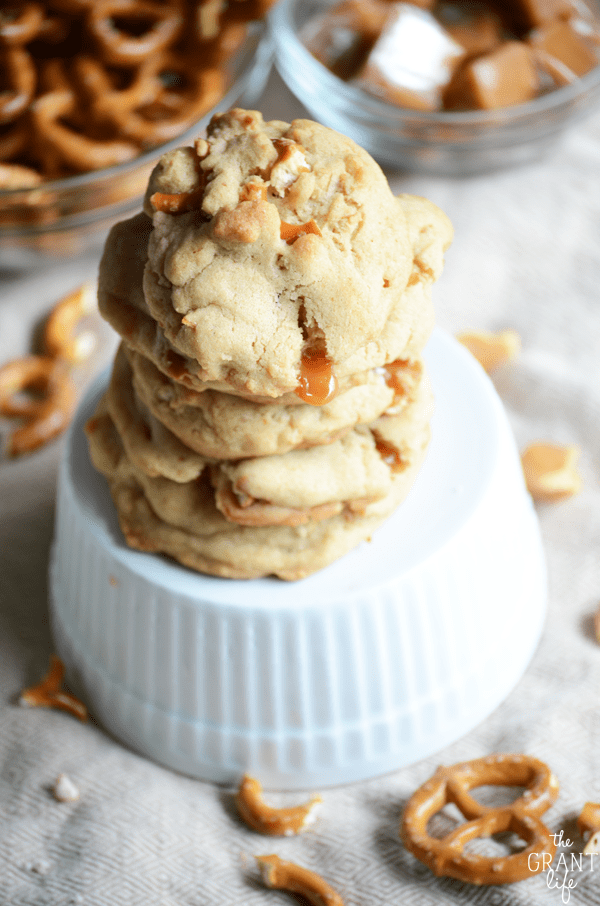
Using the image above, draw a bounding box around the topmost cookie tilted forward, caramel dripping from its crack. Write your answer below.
[144,110,451,397]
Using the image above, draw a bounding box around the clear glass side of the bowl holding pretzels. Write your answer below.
[0,22,273,270]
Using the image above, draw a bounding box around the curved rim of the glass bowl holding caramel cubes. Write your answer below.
[270,0,600,126]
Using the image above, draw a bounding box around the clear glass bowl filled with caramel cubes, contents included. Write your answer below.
[271,0,600,176]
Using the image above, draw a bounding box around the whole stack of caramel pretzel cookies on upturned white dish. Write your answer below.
[87,110,452,579]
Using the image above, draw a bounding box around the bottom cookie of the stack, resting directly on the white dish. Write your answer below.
[86,405,426,581]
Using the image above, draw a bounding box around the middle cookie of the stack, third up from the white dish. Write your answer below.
[126,349,422,459]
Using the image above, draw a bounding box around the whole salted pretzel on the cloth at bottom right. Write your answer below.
[400,754,558,884]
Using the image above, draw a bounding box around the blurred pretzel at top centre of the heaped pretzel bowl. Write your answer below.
[87,0,183,66]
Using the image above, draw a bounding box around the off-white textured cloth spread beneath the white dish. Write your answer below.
[0,77,600,906]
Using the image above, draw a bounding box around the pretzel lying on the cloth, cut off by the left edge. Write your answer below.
[0,356,75,456]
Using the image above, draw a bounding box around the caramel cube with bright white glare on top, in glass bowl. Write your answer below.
[356,3,465,110]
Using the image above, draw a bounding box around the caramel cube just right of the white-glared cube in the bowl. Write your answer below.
[444,41,539,110]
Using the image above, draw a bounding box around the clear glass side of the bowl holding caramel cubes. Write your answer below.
[271,0,600,176]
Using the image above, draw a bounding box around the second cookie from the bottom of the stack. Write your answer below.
[97,350,432,530]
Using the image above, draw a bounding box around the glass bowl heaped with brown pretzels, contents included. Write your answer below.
[0,0,272,269]
